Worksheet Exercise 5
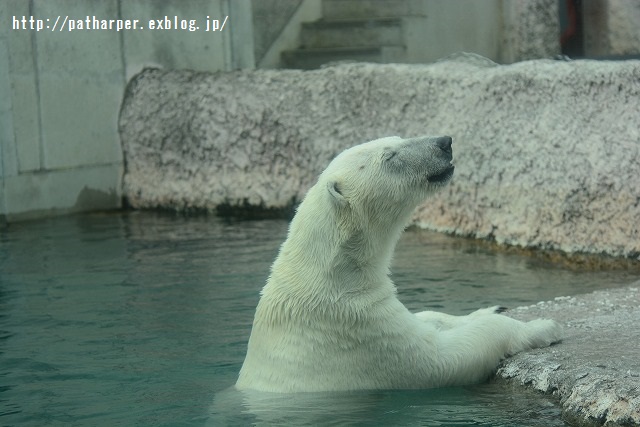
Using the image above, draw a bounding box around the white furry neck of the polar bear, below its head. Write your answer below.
[263,186,411,303]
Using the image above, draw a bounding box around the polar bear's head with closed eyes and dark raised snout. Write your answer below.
[314,136,454,231]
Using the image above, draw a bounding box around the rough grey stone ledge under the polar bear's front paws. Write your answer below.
[497,281,640,426]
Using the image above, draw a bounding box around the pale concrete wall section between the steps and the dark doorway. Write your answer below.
[404,0,560,64]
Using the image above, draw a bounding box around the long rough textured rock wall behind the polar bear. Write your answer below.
[120,55,640,258]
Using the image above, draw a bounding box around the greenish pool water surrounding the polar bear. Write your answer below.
[0,212,638,426]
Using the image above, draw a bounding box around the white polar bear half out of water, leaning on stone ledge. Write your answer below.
[236,136,561,392]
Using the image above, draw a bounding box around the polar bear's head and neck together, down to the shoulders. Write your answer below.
[274,136,454,284]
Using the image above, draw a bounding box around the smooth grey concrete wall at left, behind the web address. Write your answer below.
[0,0,254,222]
